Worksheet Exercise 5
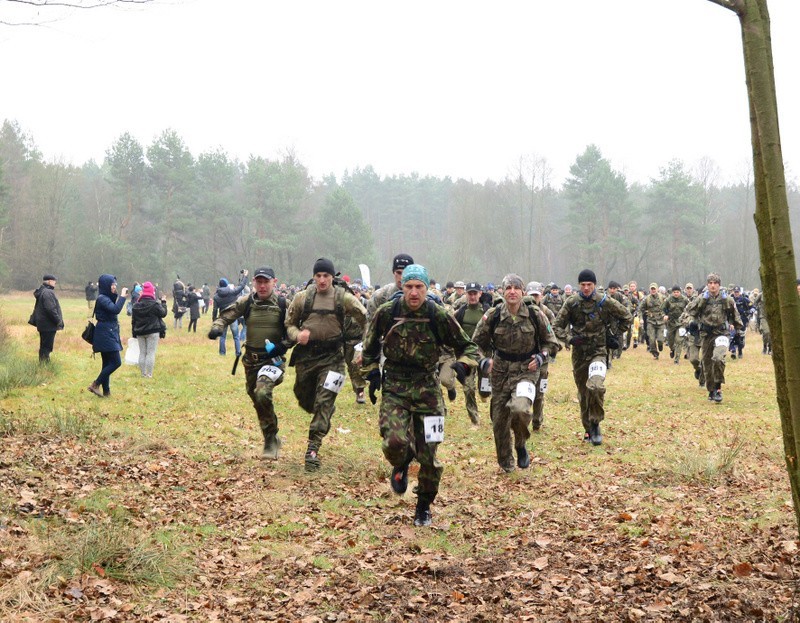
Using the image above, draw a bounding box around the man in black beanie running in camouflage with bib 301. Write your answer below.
[553,268,633,446]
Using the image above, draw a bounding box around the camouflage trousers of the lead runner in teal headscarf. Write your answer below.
[378,370,444,502]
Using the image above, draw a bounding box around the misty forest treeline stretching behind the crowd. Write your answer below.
[0,120,800,289]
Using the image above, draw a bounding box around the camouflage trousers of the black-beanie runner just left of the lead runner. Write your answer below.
[294,351,345,449]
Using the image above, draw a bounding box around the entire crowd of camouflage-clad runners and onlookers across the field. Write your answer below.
[30,260,776,526]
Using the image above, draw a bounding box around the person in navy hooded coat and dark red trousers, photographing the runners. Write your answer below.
[88,275,128,398]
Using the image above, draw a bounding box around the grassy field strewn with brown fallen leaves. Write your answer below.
[0,293,798,622]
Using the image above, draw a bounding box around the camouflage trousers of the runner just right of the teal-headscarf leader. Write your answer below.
[489,357,539,471]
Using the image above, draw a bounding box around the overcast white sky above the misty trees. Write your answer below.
[0,0,800,183]
